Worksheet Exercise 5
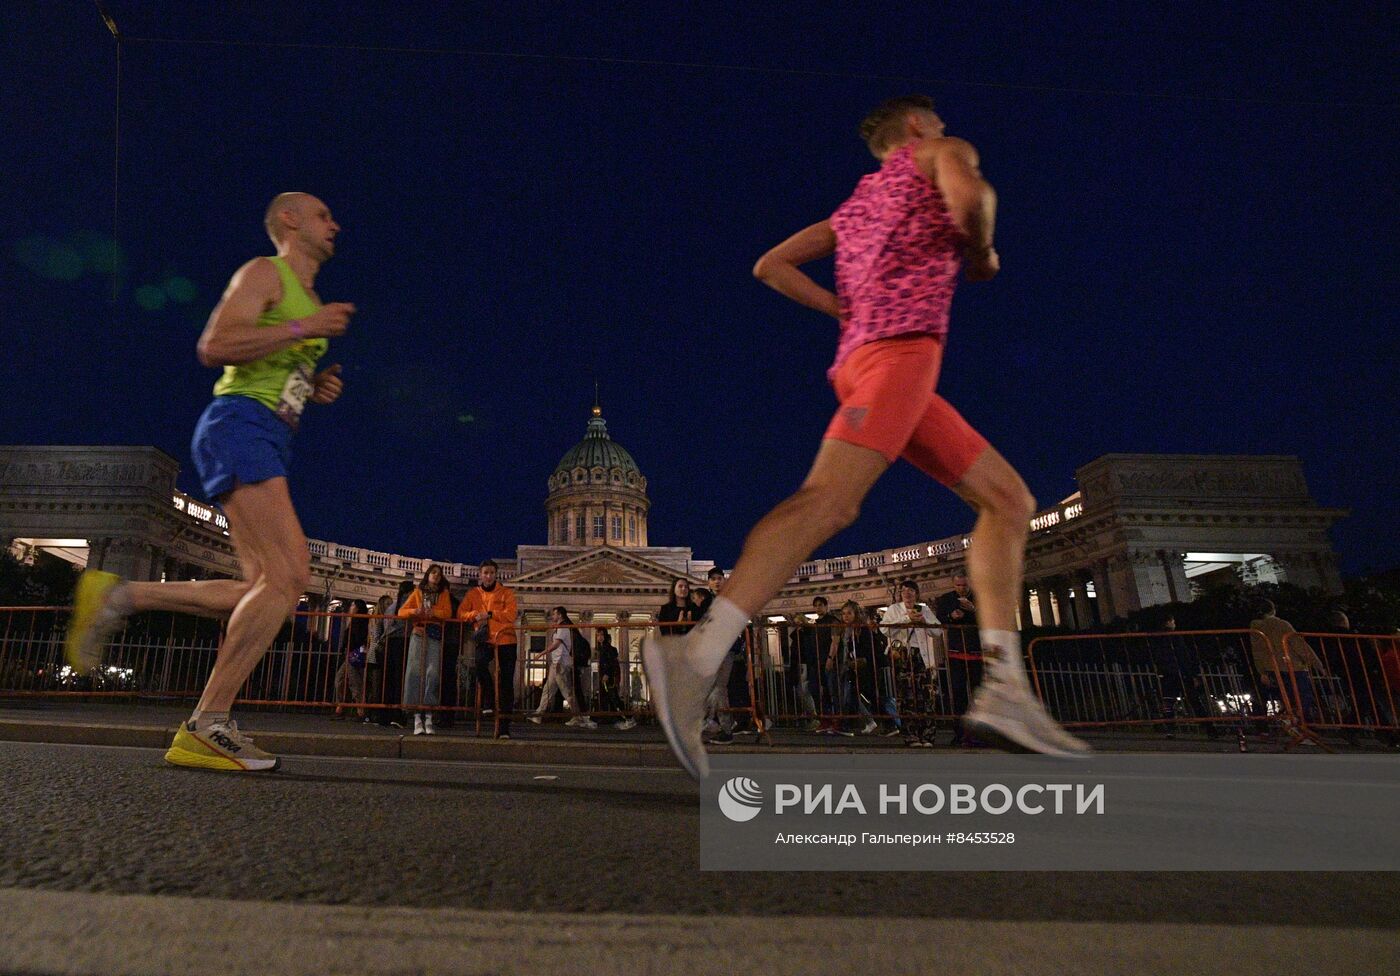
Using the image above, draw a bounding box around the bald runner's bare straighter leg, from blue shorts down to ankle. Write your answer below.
[199,477,311,711]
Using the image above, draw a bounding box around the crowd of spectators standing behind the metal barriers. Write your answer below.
[275,560,1400,748]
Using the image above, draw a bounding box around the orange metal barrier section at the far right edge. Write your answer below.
[1282,633,1400,746]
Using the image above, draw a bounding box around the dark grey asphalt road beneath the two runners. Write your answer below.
[0,742,1400,973]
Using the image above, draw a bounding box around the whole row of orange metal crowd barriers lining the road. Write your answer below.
[8,596,1400,745]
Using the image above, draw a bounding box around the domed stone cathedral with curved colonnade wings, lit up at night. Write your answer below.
[0,406,1345,644]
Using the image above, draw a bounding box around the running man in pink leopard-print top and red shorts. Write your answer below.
[643,95,1088,779]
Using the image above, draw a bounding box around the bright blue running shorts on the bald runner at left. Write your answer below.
[189,396,291,501]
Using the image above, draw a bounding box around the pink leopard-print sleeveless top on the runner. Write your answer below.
[827,146,966,377]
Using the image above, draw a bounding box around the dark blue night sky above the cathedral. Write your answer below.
[0,0,1400,571]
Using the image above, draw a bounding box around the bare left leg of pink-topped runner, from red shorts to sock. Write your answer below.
[711,438,889,615]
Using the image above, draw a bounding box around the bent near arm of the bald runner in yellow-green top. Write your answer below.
[196,258,354,365]
